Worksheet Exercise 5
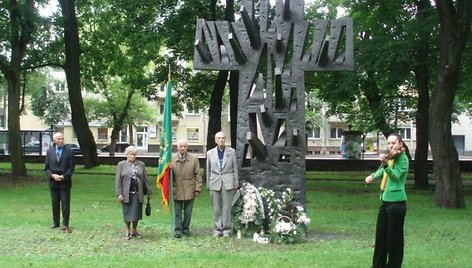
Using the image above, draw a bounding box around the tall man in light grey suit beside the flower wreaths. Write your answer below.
[206,132,239,237]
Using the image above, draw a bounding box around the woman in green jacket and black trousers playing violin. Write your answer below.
[365,133,409,267]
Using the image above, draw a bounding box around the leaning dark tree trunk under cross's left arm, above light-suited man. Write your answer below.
[207,71,228,150]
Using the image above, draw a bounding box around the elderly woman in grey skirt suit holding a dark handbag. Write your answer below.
[115,146,152,240]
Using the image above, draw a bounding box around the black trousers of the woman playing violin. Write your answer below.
[372,201,406,268]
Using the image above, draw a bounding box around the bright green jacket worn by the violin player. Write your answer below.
[374,152,410,202]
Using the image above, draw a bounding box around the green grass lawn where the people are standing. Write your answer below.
[0,163,472,268]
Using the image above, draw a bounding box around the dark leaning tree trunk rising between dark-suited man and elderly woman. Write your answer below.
[59,0,98,168]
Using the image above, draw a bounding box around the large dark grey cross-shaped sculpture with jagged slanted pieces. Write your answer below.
[193,0,354,203]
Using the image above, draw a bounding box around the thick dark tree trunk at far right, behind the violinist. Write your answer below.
[429,0,472,208]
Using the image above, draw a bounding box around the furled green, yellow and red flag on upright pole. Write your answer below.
[156,76,172,211]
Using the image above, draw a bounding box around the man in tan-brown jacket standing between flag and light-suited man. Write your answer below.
[172,139,202,238]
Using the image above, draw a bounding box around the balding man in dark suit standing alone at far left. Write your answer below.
[44,132,75,233]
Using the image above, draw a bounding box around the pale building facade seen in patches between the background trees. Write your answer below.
[0,71,472,156]
